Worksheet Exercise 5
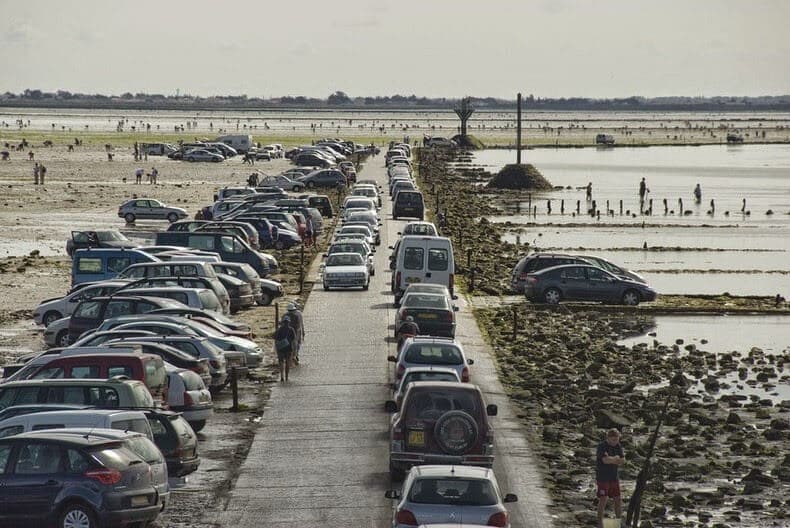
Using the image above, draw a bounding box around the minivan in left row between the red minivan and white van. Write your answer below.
[0,378,156,409]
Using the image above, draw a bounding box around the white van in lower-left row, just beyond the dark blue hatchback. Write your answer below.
[0,409,154,440]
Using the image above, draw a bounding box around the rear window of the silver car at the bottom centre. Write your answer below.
[408,477,499,506]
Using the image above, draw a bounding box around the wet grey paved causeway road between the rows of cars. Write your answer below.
[206,157,552,528]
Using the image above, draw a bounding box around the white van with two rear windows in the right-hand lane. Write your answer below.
[392,235,455,304]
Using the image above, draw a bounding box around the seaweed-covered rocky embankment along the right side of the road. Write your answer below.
[419,151,790,528]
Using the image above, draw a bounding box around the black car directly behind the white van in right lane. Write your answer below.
[395,292,458,337]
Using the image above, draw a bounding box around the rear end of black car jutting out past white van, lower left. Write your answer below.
[143,409,200,477]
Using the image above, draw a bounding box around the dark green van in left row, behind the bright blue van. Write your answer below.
[156,231,277,277]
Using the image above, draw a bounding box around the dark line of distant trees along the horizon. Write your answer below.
[0,89,790,111]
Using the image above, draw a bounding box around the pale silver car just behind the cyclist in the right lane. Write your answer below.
[387,336,474,383]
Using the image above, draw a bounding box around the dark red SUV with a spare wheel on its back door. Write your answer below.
[388,381,497,480]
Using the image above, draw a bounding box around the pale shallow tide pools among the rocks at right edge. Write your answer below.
[620,316,790,402]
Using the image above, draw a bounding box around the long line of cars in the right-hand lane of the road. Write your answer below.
[352,144,517,527]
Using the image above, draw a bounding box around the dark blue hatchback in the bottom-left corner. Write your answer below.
[0,430,160,528]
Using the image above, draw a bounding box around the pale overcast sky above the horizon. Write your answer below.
[0,0,790,98]
